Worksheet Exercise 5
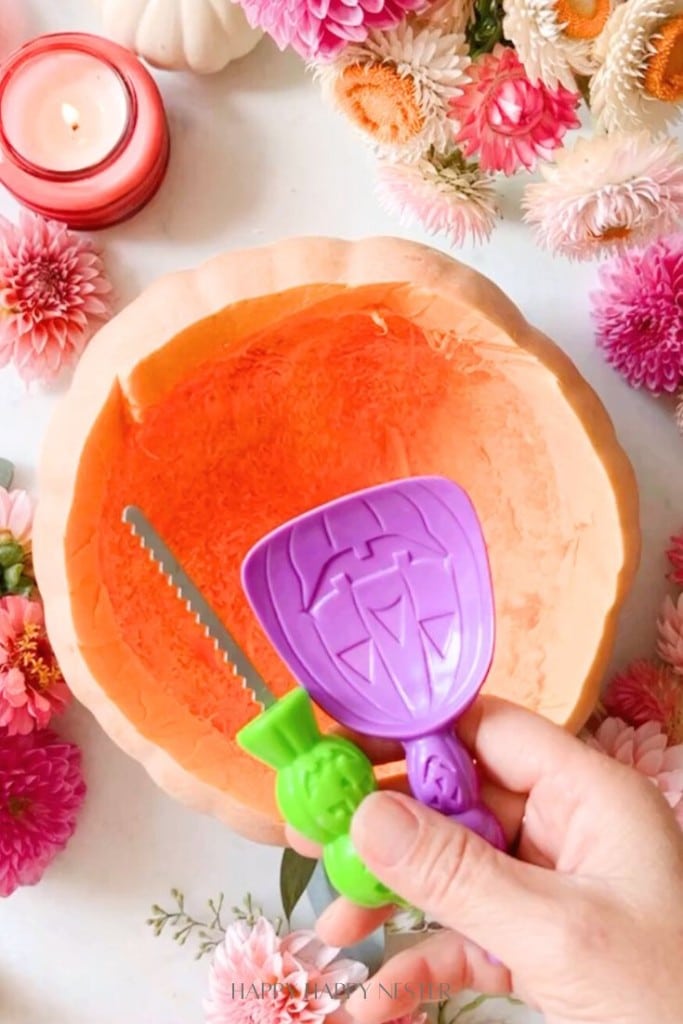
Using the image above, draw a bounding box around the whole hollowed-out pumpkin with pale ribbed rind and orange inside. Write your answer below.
[34,239,639,843]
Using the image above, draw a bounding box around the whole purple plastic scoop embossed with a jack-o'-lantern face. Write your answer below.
[242,476,504,847]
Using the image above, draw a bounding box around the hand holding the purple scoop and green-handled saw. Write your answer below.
[291,698,683,1024]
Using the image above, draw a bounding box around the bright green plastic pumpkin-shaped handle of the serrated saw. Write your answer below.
[237,688,401,907]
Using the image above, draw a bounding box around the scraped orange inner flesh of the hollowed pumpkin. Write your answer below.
[67,286,630,817]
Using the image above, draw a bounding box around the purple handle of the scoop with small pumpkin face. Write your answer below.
[403,730,506,850]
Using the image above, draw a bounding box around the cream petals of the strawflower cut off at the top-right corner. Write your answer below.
[590,0,680,134]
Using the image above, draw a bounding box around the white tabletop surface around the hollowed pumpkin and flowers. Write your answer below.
[0,0,683,1024]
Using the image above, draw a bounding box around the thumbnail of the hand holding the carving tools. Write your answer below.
[351,793,420,867]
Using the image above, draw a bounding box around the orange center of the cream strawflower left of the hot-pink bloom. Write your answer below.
[335,63,425,145]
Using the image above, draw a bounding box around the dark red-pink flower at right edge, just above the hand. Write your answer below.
[602,660,683,742]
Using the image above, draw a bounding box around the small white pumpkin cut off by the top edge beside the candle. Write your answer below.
[96,0,263,75]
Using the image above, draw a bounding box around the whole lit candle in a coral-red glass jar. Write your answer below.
[0,34,169,229]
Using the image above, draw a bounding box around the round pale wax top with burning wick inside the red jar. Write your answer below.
[0,50,130,171]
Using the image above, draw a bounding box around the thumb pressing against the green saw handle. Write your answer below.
[351,793,564,969]
